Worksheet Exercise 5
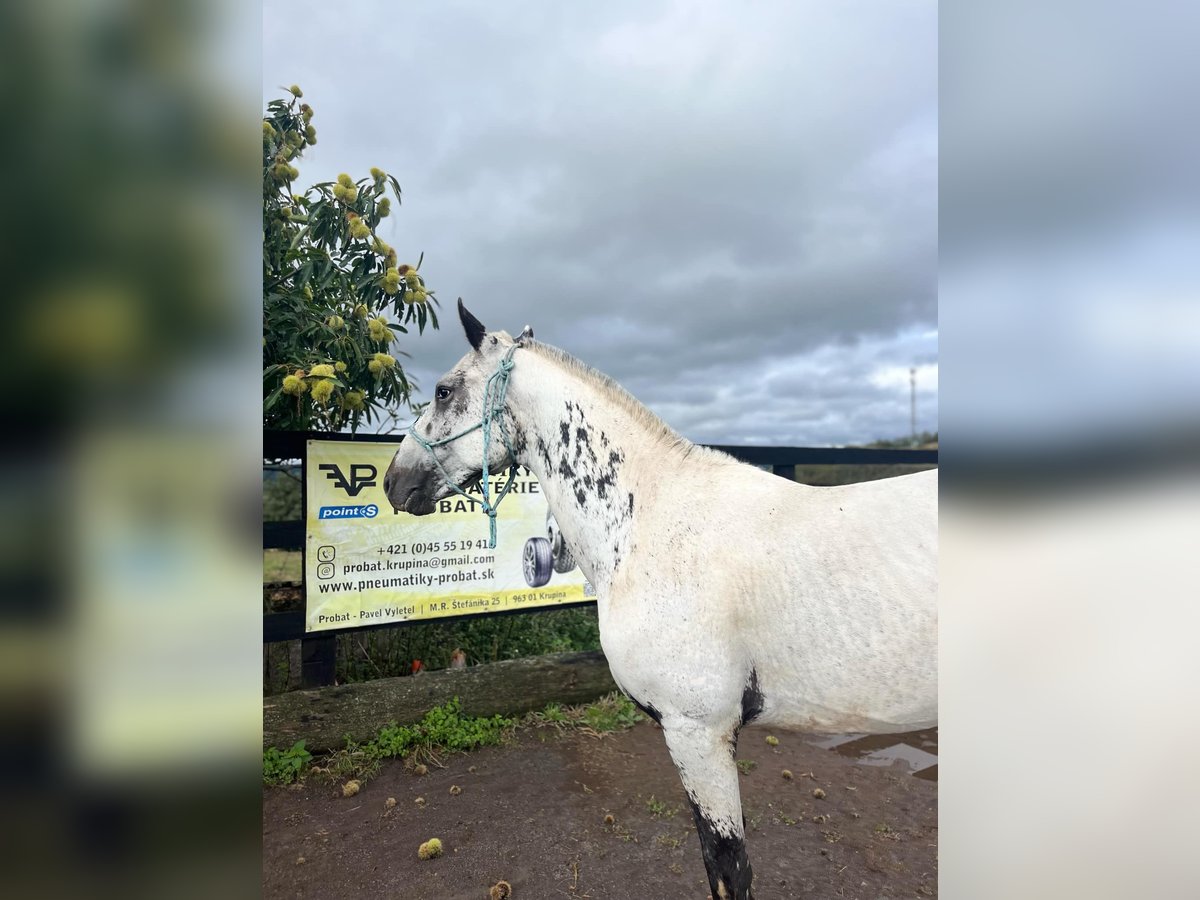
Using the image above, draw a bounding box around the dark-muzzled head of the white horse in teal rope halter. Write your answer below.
[383,300,520,516]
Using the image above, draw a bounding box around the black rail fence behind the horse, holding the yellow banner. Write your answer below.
[263,431,937,688]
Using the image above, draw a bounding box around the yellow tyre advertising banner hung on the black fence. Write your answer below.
[305,440,595,631]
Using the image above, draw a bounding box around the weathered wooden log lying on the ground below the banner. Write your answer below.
[263,650,617,751]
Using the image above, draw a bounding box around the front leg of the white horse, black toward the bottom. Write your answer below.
[661,718,754,900]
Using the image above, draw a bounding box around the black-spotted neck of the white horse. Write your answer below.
[509,352,659,590]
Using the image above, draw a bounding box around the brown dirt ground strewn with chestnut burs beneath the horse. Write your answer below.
[263,722,937,900]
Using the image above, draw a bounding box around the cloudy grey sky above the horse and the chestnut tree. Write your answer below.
[263,0,938,445]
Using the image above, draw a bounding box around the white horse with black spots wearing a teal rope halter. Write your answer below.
[384,300,937,900]
